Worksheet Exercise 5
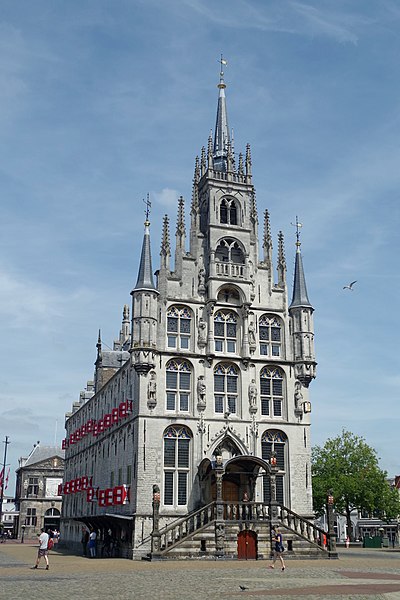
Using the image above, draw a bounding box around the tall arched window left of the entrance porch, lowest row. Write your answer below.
[163,425,192,506]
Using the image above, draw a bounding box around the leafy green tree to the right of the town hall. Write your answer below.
[311,430,400,538]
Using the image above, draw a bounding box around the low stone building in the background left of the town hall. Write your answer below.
[15,442,64,539]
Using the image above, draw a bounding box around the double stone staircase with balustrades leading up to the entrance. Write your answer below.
[148,501,329,559]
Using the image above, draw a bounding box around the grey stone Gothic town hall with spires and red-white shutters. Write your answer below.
[60,62,316,559]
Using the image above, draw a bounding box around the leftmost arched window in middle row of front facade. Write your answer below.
[165,359,192,412]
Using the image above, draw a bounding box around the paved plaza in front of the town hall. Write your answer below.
[0,542,400,600]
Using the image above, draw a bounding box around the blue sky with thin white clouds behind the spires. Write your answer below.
[0,0,400,492]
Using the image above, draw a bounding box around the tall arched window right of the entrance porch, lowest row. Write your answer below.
[261,429,287,504]
